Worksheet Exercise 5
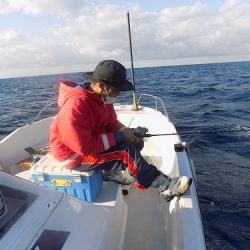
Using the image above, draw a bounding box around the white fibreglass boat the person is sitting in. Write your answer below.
[0,105,206,250]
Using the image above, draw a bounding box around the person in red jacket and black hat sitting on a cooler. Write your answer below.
[50,60,192,201]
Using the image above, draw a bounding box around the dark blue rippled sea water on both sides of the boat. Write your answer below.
[0,62,250,250]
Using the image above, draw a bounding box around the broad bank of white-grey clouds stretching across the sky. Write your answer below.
[0,0,250,75]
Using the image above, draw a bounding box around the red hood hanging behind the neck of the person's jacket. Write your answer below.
[58,81,102,108]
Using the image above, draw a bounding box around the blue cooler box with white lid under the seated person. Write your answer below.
[30,153,102,202]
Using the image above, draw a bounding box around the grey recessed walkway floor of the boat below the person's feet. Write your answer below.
[123,186,168,250]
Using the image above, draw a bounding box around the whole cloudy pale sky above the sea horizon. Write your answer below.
[0,0,250,78]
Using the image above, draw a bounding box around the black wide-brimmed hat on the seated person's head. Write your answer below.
[84,60,134,91]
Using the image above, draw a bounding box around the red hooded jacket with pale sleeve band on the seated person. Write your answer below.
[50,81,125,168]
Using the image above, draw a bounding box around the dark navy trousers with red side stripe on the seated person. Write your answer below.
[76,143,159,189]
